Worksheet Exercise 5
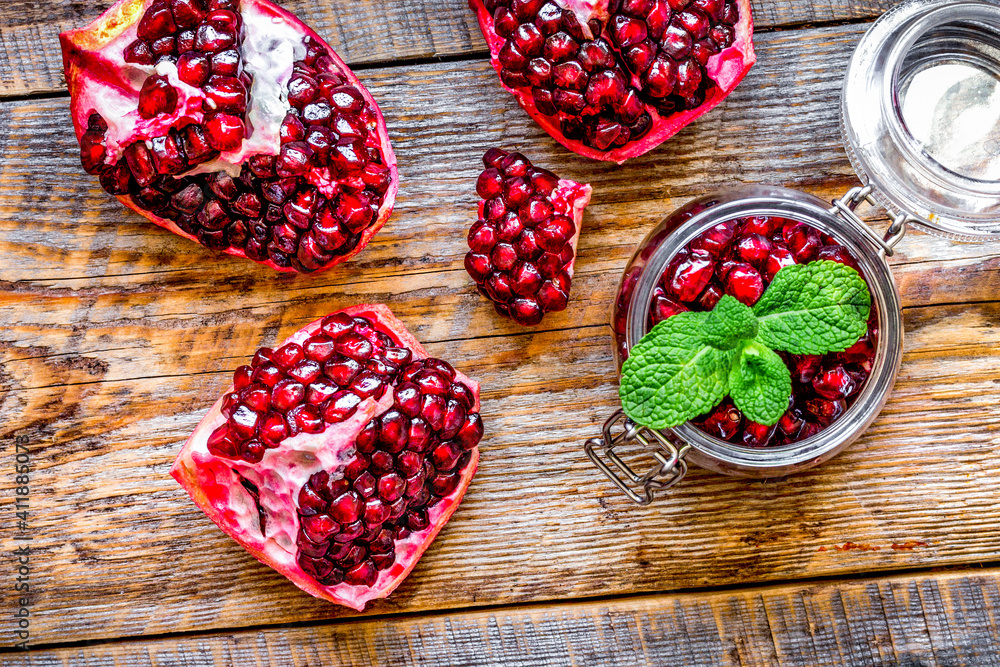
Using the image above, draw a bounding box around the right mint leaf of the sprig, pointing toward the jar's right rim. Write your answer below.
[753,260,872,354]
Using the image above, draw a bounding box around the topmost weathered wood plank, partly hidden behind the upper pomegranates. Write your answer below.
[0,0,892,97]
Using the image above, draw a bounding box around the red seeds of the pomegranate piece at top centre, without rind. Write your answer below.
[485,0,739,151]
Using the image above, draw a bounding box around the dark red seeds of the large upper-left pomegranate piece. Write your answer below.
[80,0,392,272]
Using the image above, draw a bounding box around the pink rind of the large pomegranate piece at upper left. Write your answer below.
[59,0,399,272]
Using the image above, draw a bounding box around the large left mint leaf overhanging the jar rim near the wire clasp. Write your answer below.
[619,312,739,429]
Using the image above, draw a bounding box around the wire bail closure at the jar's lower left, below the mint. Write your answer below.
[583,410,691,505]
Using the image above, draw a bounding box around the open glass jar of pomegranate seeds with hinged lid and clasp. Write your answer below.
[585,0,1000,505]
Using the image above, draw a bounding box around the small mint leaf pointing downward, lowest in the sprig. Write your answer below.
[729,341,792,426]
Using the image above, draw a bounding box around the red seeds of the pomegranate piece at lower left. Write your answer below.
[208,313,483,586]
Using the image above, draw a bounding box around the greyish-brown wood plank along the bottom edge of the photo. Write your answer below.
[0,569,1000,667]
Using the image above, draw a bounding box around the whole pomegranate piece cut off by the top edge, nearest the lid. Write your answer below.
[469,0,756,163]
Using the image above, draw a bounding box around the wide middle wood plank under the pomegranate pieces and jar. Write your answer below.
[0,11,1000,655]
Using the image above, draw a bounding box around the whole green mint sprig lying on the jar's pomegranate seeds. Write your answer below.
[619,261,871,429]
